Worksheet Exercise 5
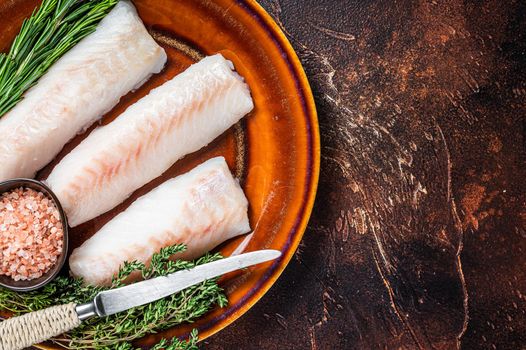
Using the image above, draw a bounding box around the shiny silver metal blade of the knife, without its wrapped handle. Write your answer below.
[76,249,281,321]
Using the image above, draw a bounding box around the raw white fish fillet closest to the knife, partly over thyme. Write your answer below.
[69,157,250,285]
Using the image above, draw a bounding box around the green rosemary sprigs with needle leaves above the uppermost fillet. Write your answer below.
[0,0,118,117]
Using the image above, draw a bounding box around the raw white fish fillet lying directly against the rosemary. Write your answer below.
[0,1,166,181]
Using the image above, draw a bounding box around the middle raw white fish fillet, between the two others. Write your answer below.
[47,55,254,227]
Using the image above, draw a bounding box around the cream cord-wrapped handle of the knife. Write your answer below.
[0,303,80,350]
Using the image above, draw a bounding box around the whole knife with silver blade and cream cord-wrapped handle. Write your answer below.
[0,250,281,350]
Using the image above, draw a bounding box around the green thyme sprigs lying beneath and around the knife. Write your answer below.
[0,244,227,350]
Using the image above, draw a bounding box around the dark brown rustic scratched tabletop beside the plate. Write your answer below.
[204,0,526,349]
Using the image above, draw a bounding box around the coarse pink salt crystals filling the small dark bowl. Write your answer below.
[0,188,64,281]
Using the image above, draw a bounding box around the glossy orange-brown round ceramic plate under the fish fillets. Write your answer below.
[0,0,320,346]
